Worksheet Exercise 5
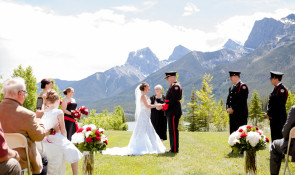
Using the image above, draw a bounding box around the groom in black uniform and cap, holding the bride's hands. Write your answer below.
[158,71,182,153]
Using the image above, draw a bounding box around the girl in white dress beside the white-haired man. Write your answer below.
[41,90,83,175]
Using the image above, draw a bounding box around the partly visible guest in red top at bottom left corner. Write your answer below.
[0,123,21,175]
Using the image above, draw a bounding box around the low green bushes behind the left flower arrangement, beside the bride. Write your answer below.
[82,106,128,131]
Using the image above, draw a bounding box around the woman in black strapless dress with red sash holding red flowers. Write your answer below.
[62,87,79,140]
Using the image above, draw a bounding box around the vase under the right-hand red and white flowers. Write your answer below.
[245,151,257,175]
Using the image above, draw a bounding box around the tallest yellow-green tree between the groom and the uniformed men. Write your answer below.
[196,74,215,131]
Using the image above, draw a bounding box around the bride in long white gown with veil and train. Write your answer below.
[102,82,166,156]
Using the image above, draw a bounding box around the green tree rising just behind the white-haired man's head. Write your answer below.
[12,65,37,111]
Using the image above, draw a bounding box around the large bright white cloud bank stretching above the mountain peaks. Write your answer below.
[0,0,290,80]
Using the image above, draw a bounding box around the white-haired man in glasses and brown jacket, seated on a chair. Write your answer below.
[0,78,49,174]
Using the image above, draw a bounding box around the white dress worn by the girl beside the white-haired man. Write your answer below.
[41,109,83,175]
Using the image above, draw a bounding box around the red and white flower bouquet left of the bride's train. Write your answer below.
[72,124,108,154]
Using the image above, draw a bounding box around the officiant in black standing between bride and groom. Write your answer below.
[150,85,167,141]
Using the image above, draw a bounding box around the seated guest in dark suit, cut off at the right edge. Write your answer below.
[270,106,295,175]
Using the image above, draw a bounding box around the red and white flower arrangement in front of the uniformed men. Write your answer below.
[228,125,269,153]
